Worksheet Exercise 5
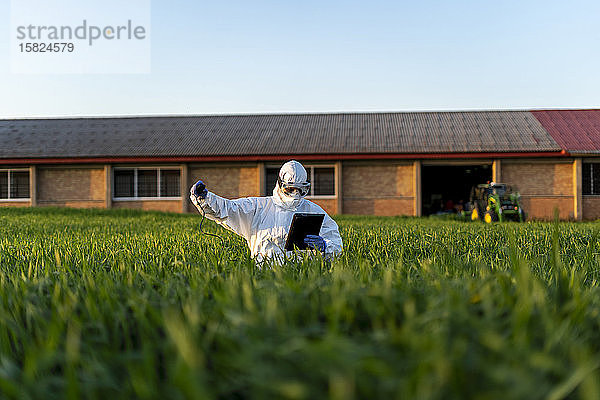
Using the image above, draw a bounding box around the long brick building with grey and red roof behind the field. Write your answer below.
[0,110,600,220]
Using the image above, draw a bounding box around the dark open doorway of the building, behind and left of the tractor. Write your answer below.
[421,165,492,215]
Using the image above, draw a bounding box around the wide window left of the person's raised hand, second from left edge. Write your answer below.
[113,168,181,199]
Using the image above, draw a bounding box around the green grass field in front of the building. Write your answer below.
[0,209,600,399]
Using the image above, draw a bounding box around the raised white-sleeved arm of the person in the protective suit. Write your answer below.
[190,192,257,240]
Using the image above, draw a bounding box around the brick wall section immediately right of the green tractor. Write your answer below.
[502,161,585,219]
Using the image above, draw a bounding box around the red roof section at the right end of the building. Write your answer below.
[532,110,600,154]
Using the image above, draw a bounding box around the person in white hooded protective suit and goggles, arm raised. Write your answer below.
[190,161,342,262]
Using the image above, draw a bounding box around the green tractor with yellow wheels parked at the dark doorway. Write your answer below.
[470,182,525,224]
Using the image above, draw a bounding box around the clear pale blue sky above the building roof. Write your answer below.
[0,0,600,118]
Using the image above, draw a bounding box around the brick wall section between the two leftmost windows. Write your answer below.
[36,167,106,208]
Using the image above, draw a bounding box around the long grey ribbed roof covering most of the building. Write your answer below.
[0,111,562,159]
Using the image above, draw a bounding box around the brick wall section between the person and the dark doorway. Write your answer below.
[342,162,415,215]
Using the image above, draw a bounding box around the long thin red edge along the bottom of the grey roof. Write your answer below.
[0,150,570,165]
